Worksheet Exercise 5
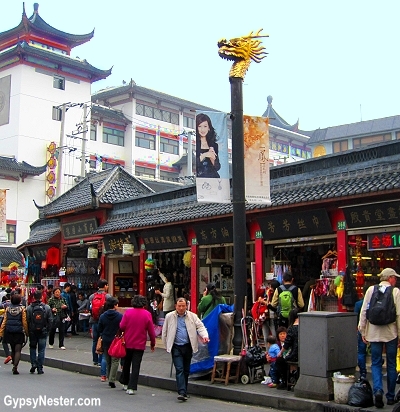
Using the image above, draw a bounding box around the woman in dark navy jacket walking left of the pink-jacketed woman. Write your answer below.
[98,297,122,388]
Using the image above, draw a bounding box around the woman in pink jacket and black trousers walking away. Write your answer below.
[119,295,156,395]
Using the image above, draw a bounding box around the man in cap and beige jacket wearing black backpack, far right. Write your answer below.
[358,268,400,408]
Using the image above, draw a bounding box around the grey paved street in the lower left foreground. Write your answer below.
[0,362,292,412]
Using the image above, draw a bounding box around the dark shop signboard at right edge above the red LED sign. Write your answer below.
[343,202,400,229]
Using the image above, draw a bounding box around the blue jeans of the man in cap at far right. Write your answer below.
[371,338,397,399]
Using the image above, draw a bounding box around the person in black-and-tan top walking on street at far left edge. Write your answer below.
[0,293,28,375]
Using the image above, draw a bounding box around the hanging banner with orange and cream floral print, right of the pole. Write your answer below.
[243,116,271,204]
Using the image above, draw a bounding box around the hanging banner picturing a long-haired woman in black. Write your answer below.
[196,111,231,203]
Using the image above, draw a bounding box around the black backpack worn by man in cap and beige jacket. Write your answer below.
[367,285,396,325]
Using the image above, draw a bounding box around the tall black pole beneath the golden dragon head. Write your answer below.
[229,77,247,355]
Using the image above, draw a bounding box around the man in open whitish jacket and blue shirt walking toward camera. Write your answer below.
[162,298,210,401]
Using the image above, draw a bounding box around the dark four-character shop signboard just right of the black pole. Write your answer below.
[257,209,333,240]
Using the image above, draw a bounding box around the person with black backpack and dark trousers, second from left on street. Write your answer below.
[26,290,53,375]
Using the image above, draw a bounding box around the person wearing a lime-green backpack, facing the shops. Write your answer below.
[268,272,304,328]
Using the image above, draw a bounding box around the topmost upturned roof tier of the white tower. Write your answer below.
[0,3,94,49]
